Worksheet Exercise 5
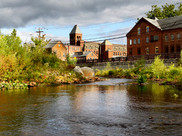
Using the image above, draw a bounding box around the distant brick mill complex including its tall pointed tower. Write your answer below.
[47,25,127,60]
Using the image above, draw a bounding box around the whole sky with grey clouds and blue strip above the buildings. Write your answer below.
[0,0,181,44]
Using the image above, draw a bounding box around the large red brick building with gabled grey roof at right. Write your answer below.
[126,16,182,58]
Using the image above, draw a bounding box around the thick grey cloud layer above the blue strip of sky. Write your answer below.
[0,0,181,28]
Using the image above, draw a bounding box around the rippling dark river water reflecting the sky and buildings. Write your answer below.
[0,79,182,136]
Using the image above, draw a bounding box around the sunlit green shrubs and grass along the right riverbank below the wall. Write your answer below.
[96,54,182,89]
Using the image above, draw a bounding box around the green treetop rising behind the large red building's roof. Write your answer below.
[146,3,182,19]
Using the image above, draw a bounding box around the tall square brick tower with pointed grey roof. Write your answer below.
[70,25,83,46]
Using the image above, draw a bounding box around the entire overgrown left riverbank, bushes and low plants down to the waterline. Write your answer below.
[0,29,90,89]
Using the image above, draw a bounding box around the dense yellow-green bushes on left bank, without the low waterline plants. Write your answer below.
[0,29,69,87]
